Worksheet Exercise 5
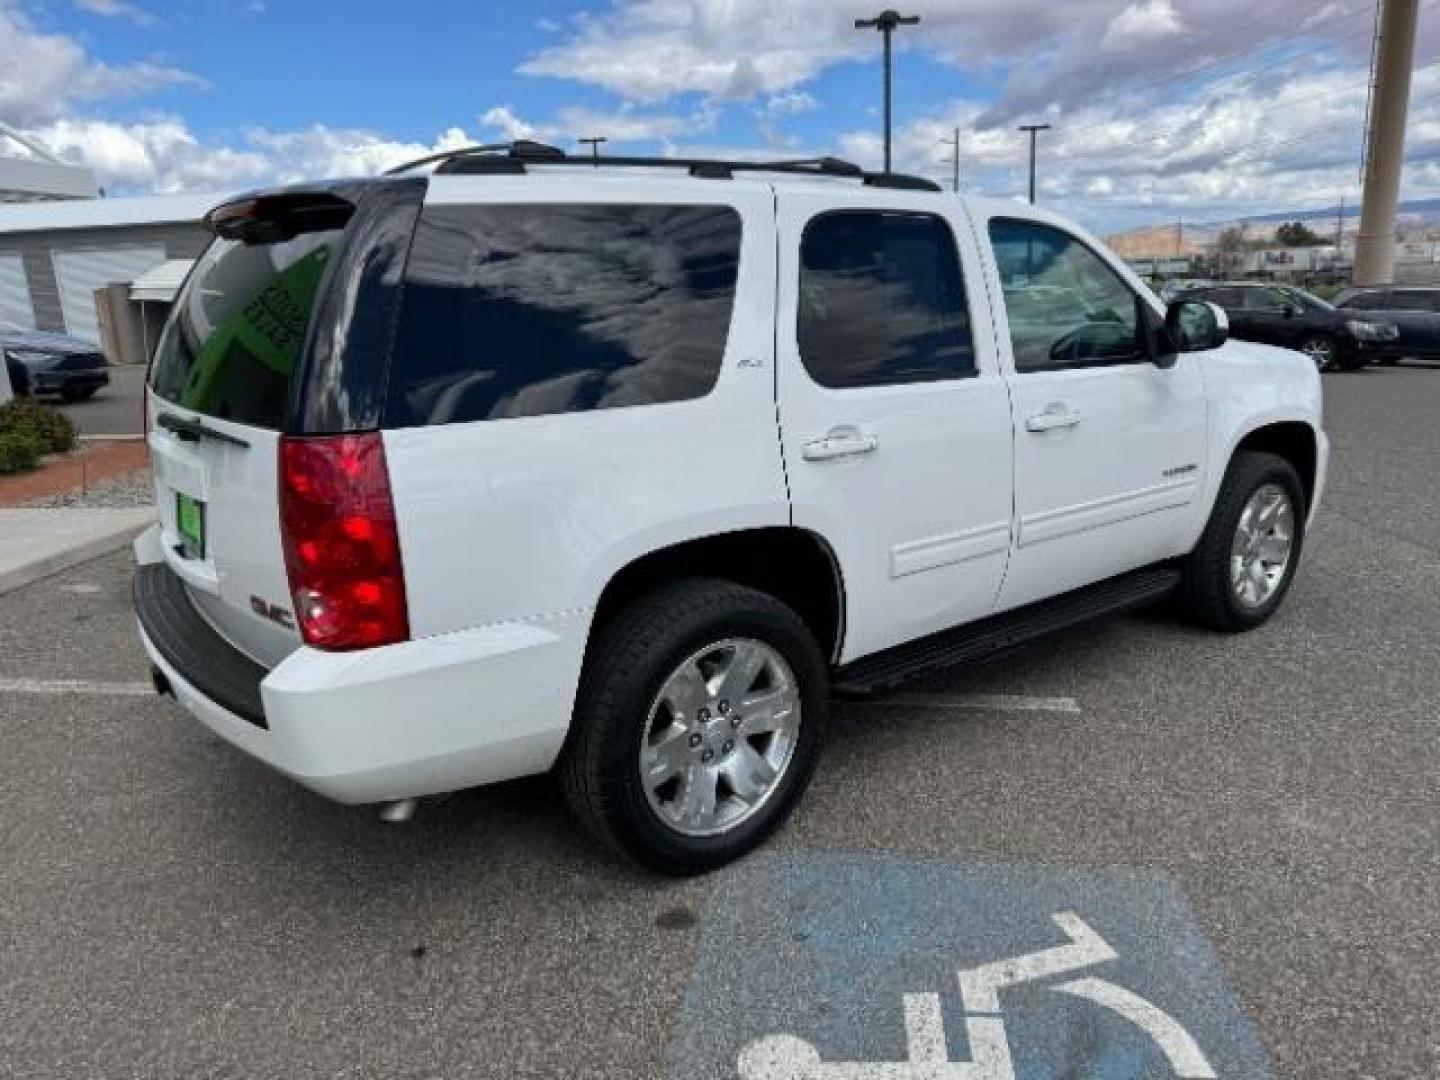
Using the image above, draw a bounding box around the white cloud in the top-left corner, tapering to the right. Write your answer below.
[0,0,206,125]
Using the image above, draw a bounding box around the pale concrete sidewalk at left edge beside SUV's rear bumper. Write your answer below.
[0,507,156,593]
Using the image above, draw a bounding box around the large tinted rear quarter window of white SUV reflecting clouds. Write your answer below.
[386,204,740,426]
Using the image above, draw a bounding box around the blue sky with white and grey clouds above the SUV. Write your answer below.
[0,0,1440,230]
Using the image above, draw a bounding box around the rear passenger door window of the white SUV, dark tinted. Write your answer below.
[798,210,975,389]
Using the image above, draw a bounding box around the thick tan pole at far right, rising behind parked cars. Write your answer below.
[1352,0,1420,285]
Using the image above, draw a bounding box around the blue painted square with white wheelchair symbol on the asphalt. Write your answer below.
[672,855,1270,1080]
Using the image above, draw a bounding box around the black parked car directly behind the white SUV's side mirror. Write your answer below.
[1178,281,1400,372]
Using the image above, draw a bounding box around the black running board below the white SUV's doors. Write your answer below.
[831,566,1179,697]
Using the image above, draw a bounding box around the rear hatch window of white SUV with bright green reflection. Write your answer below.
[150,230,341,429]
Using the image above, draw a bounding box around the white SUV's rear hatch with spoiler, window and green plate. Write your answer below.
[145,184,418,667]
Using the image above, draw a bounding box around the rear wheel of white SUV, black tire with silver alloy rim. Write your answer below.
[557,579,828,874]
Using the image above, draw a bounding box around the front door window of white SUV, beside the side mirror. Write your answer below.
[989,219,1149,372]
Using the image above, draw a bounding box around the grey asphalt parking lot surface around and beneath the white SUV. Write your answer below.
[0,369,1440,1080]
